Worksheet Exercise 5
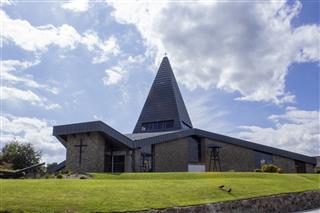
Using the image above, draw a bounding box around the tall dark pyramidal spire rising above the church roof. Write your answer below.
[133,56,192,133]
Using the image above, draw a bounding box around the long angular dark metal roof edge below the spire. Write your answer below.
[53,121,316,164]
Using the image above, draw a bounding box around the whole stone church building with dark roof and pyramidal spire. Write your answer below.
[53,57,316,173]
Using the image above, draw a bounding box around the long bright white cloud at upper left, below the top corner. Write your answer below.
[0,10,120,63]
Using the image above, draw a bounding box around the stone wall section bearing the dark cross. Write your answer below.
[66,133,105,172]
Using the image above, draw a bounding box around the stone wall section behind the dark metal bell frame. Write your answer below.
[203,139,255,172]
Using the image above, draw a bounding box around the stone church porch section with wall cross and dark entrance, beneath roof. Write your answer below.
[57,132,140,172]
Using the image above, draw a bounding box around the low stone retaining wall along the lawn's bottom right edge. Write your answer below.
[137,190,320,213]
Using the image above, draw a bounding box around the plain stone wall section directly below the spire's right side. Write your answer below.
[154,138,188,172]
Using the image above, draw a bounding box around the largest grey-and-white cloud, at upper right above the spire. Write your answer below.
[111,1,320,104]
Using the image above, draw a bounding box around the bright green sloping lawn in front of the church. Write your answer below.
[0,172,320,212]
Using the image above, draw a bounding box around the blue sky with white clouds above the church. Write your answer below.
[0,0,320,162]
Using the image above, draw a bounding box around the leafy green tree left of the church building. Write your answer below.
[0,141,41,169]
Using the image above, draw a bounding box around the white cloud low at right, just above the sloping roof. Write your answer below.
[239,107,320,156]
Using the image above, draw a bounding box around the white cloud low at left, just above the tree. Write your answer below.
[0,114,65,162]
